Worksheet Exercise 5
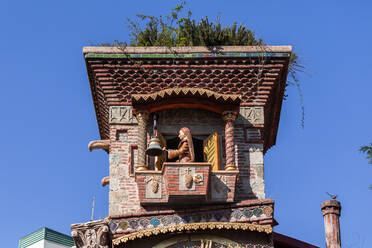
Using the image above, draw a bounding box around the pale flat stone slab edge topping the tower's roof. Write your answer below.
[83,46,292,54]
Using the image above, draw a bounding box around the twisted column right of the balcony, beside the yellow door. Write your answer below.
[222,111,237,170]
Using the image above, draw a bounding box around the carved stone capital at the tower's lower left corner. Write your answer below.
[71,220,110,248]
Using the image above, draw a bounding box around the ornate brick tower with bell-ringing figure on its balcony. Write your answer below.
[71,46,294,248]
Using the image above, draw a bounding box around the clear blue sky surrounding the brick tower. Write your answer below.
[0,0,372,248]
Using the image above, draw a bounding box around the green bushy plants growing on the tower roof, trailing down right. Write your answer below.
[100,1,305,127]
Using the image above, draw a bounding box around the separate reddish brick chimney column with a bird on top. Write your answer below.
[322,200,341,248]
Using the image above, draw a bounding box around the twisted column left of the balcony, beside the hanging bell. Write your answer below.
[136,111,149,170]
